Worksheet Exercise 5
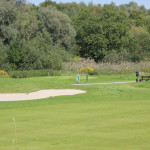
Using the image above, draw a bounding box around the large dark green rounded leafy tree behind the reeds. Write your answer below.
[74,4,130,61]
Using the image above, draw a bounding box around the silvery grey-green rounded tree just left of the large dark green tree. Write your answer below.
[38,6,76,51]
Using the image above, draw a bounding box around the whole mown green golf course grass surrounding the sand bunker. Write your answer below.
[0,75,150,150]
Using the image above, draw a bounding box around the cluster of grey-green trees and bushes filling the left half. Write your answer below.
[0,0,76,72]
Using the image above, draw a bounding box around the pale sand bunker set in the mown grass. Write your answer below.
[0,89,85,101]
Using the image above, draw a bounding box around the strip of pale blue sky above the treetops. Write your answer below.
[28,0,150,9]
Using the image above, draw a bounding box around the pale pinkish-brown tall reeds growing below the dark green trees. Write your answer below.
[65,59,150,74]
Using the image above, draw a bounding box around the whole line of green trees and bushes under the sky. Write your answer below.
[0,0,150,70]
